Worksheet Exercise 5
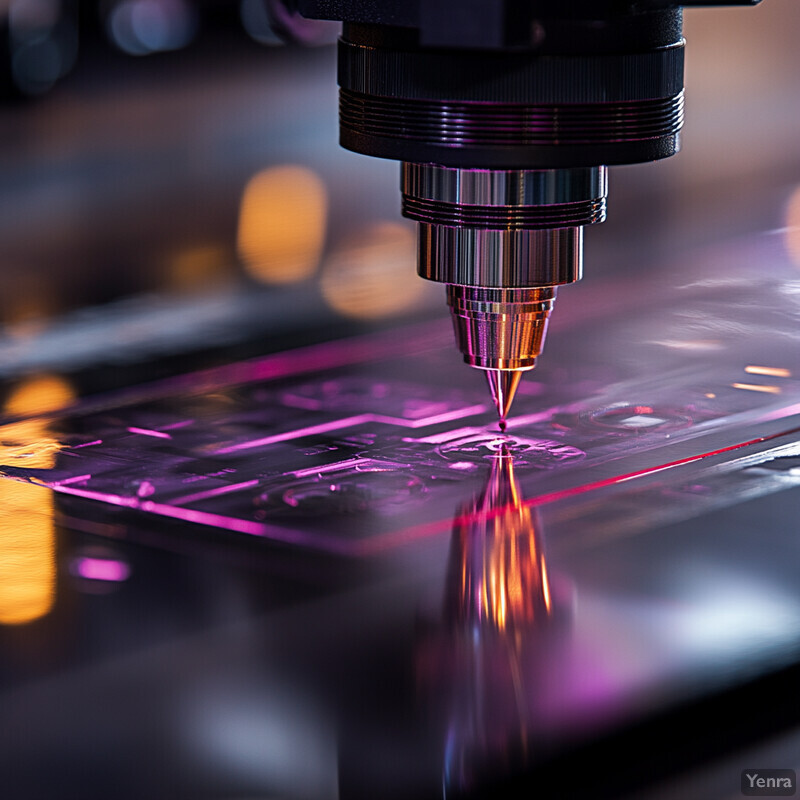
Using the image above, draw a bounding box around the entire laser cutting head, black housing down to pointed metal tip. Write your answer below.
[286,0,758,420]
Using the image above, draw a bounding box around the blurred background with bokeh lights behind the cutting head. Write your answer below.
[0,0,800,391]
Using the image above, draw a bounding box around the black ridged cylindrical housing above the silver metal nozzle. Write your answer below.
[339,8,683,169]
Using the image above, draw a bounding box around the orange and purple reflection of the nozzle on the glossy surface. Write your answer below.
[434,448,563,792]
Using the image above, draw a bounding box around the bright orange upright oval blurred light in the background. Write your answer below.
[237,166,328,284]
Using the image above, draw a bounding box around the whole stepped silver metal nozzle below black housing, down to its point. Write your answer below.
[402,163,607,418]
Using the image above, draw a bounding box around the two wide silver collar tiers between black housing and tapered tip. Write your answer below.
[402,164,608,289]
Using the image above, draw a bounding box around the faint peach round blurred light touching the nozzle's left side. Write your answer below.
[321,222,425,319]
